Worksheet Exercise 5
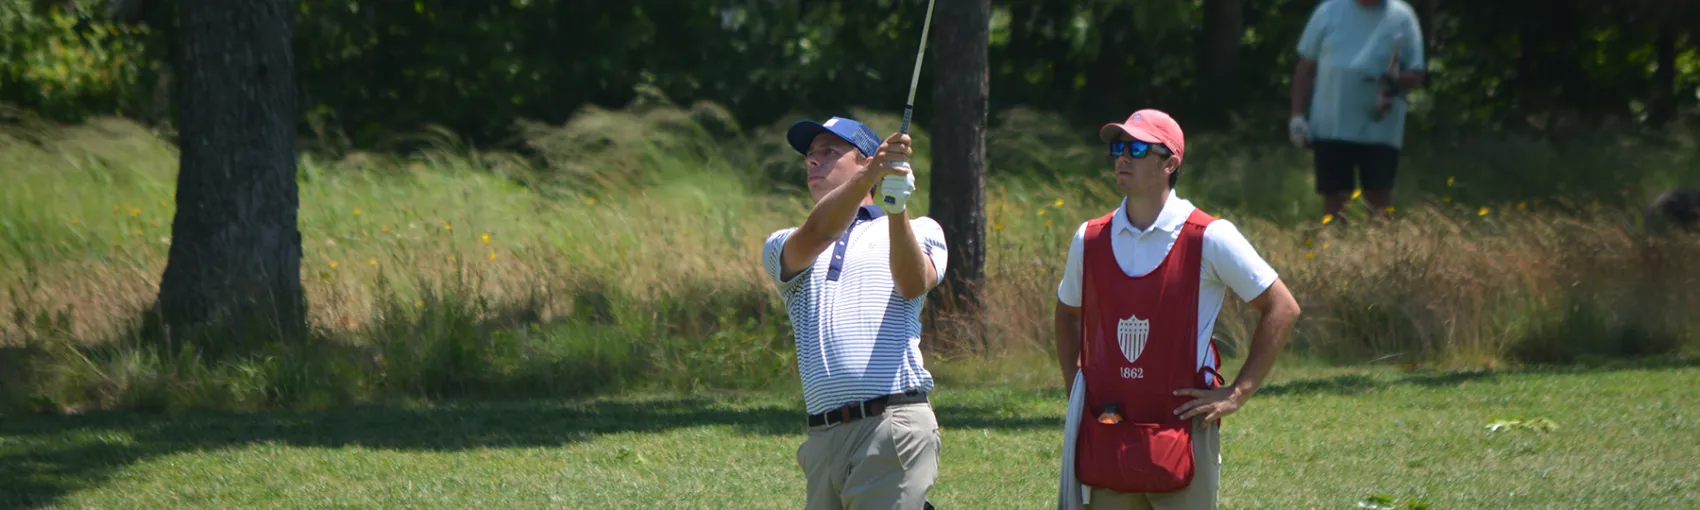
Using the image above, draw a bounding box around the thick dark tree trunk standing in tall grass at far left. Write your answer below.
[155,0,306,355]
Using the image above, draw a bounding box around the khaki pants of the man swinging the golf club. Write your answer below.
[797,403,940,510]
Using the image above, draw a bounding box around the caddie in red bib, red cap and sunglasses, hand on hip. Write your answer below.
[1056,109,1299,510]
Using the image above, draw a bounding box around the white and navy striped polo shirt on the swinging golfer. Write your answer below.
[762,206,947,415]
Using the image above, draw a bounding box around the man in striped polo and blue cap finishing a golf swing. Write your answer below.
[762,117,947,510]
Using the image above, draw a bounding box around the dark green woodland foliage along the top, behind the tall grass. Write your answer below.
[13,0,1700,151]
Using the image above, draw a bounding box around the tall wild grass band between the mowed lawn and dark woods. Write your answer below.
[0,100,1700,416]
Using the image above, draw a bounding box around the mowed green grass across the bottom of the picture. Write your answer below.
[0,359,1700,508]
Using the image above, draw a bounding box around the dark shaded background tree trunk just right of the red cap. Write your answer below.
[1199,0,1246,117]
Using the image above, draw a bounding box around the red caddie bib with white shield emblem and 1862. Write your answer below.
[1074,209,1221,493]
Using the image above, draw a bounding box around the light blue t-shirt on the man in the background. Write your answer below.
[1299,0,1425,148]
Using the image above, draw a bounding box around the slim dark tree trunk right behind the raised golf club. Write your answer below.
[928,0,991,350]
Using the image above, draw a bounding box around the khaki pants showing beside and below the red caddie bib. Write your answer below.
[1086,418,1222,510]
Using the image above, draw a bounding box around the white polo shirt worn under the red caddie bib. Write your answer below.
[1057,190,1277,375]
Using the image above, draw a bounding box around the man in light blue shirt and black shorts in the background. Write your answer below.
[1287,0,1425,221]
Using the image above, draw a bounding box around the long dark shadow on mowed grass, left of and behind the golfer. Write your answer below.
[0,391,1061,508]
